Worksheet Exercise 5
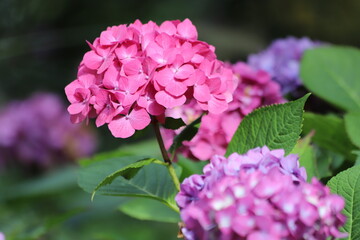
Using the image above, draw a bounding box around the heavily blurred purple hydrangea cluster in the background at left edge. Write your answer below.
[0,93,96,167]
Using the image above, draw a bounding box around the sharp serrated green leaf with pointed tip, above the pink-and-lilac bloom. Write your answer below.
[226,94,310,155]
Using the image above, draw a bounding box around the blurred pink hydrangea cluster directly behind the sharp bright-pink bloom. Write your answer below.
[162,62,285,160]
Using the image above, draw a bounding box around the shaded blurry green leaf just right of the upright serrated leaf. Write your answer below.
[303,113,356,161]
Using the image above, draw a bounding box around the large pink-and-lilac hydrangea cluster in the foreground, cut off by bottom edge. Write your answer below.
[176,147,346,240]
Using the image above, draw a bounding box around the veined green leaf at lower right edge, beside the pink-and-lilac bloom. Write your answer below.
[327,166,360,240]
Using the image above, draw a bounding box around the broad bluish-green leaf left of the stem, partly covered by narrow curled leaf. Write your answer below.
[78,156,178,210]
